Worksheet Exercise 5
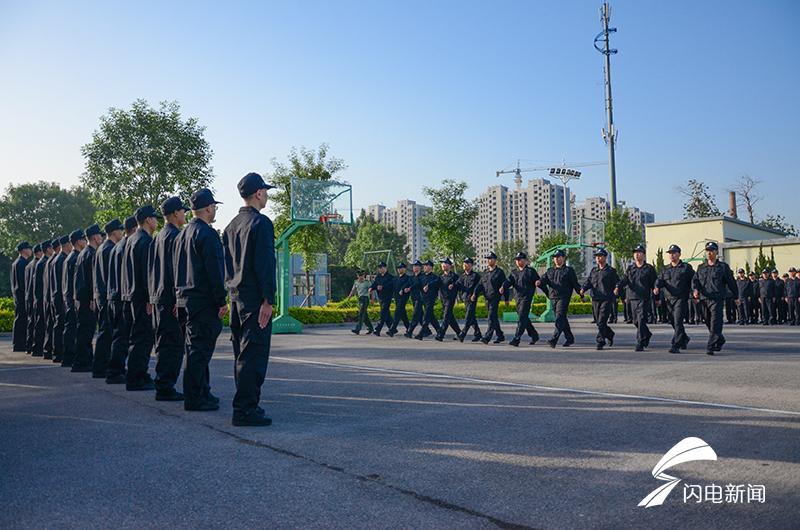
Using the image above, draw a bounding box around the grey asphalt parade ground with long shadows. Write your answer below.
[0,318,800,529]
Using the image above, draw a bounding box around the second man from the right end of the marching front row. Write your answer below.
[653,245,694,353]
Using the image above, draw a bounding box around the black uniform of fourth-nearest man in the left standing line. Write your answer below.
[120,227,155,389]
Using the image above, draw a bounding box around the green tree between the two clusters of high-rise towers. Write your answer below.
[420,179,478,262]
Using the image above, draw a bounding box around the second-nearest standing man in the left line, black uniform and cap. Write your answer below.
[173,188,228,411]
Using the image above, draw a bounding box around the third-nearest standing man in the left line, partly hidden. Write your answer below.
[147,197,188,401]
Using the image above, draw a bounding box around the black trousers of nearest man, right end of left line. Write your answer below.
[231,301,272,416]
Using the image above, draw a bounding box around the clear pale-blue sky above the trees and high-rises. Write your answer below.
[0,0,800,226]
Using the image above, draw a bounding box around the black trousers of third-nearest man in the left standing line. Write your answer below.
[153,304,186,392]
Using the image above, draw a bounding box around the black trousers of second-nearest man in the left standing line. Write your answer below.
[184,305,222,403]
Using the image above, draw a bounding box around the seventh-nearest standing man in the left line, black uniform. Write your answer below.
[72,224,105,372]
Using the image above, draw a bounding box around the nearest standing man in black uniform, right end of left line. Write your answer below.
[222,173,277,427]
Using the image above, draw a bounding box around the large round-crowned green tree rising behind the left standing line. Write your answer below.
[81,99,214,222]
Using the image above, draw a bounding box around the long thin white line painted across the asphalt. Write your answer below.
[272,356,800,416]
